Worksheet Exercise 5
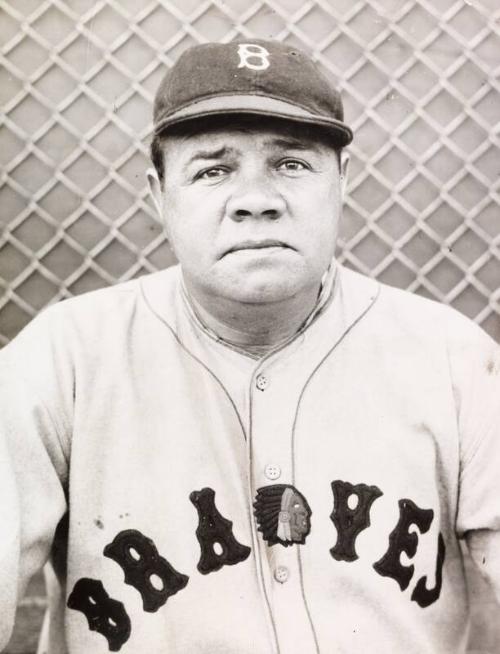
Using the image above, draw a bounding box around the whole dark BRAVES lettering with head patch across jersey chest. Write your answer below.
[68,479,445,651]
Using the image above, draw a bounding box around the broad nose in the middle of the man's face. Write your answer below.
[226,176,286,222]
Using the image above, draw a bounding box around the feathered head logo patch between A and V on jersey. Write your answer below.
[254,484,312,547]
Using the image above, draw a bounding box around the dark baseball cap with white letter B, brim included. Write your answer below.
[153,39,352,146]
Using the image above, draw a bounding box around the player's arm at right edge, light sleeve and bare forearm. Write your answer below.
[450,318,500,602]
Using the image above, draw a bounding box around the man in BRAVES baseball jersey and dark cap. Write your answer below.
[0,41,500,654]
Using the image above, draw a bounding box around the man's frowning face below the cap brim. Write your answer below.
[152,119,348,303]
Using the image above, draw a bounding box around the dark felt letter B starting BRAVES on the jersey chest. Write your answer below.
[68,578,130,652]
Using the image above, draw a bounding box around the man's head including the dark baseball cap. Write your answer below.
[150,41,352,316]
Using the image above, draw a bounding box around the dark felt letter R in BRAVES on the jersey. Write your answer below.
[103,529,189,613]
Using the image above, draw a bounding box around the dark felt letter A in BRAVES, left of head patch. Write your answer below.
[189,488,251,575]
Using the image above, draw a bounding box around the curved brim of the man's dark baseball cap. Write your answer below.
[154,95,353,146]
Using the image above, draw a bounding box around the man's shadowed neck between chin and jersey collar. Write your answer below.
[186,285,320,354]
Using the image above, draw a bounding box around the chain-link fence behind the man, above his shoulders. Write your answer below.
[0,0,500,344]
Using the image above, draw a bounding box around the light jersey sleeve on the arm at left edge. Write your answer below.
[0,310,70,651]
